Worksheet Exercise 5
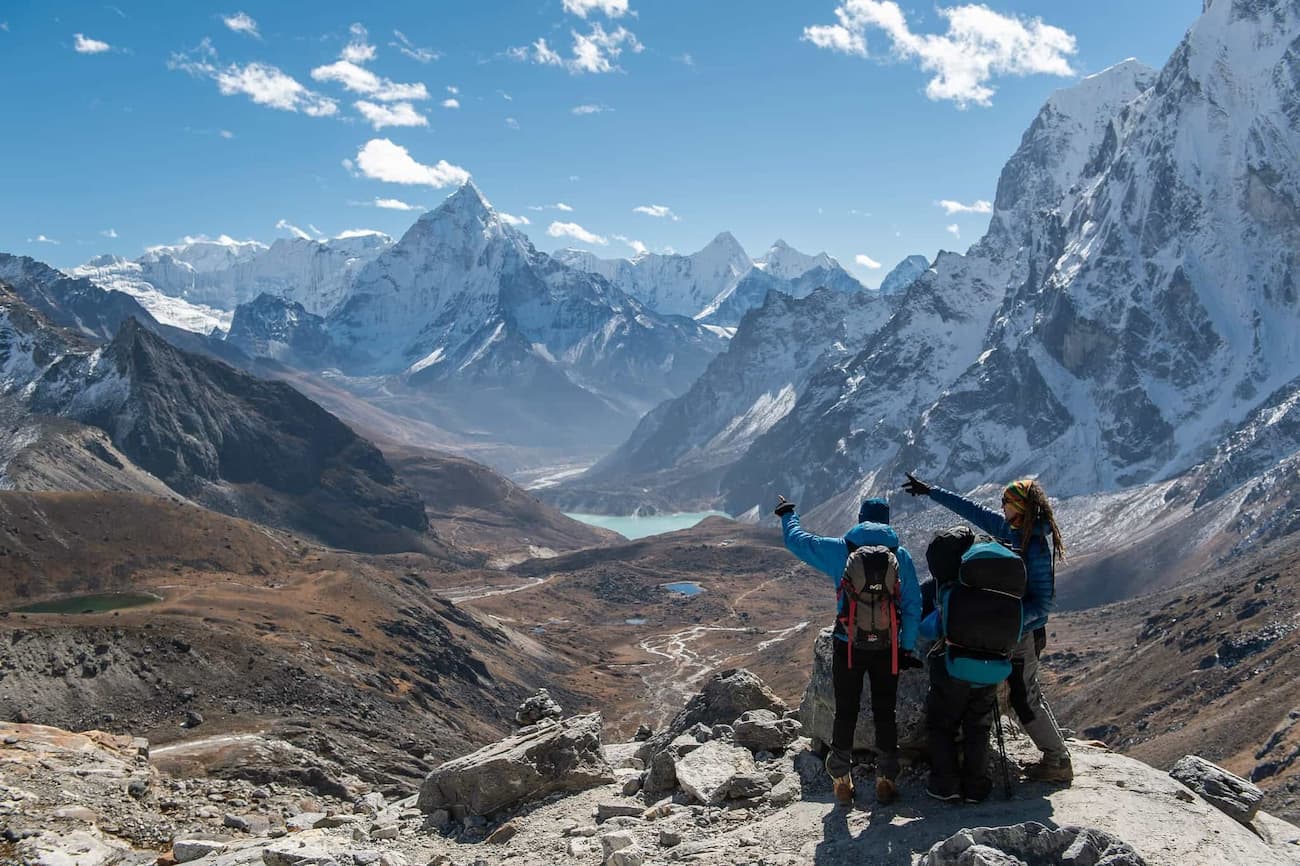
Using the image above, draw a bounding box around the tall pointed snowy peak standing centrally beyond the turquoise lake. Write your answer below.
[326,183,723,436]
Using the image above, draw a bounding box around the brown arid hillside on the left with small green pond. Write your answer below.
[0,492,595,789]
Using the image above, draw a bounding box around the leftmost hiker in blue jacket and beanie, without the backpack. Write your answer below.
[776,497,922,805]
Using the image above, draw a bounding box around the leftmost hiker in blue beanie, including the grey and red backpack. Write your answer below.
[776,497,922,806]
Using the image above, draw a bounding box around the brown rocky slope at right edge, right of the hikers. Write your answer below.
[1044,525,1300,820]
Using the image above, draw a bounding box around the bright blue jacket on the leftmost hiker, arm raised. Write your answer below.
[781,511,920,653]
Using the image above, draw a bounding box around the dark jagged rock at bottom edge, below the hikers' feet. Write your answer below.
[920,822,1147,866]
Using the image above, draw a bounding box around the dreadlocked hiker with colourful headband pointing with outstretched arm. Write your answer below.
[902,472,1074,785]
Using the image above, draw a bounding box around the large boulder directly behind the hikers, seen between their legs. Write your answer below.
[800,628,930,755]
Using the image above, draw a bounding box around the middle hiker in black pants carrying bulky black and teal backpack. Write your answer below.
[920,527,1026,802]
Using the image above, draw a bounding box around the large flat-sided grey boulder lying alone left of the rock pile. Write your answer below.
[416,714,614,815]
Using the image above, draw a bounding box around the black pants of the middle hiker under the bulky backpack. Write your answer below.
[926,655,997,802]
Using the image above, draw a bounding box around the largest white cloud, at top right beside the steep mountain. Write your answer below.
[803,0,1076,108]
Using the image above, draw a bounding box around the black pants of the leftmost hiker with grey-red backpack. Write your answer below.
[827,638,898,779]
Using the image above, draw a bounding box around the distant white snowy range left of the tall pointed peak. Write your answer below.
[70,231,393,333]
